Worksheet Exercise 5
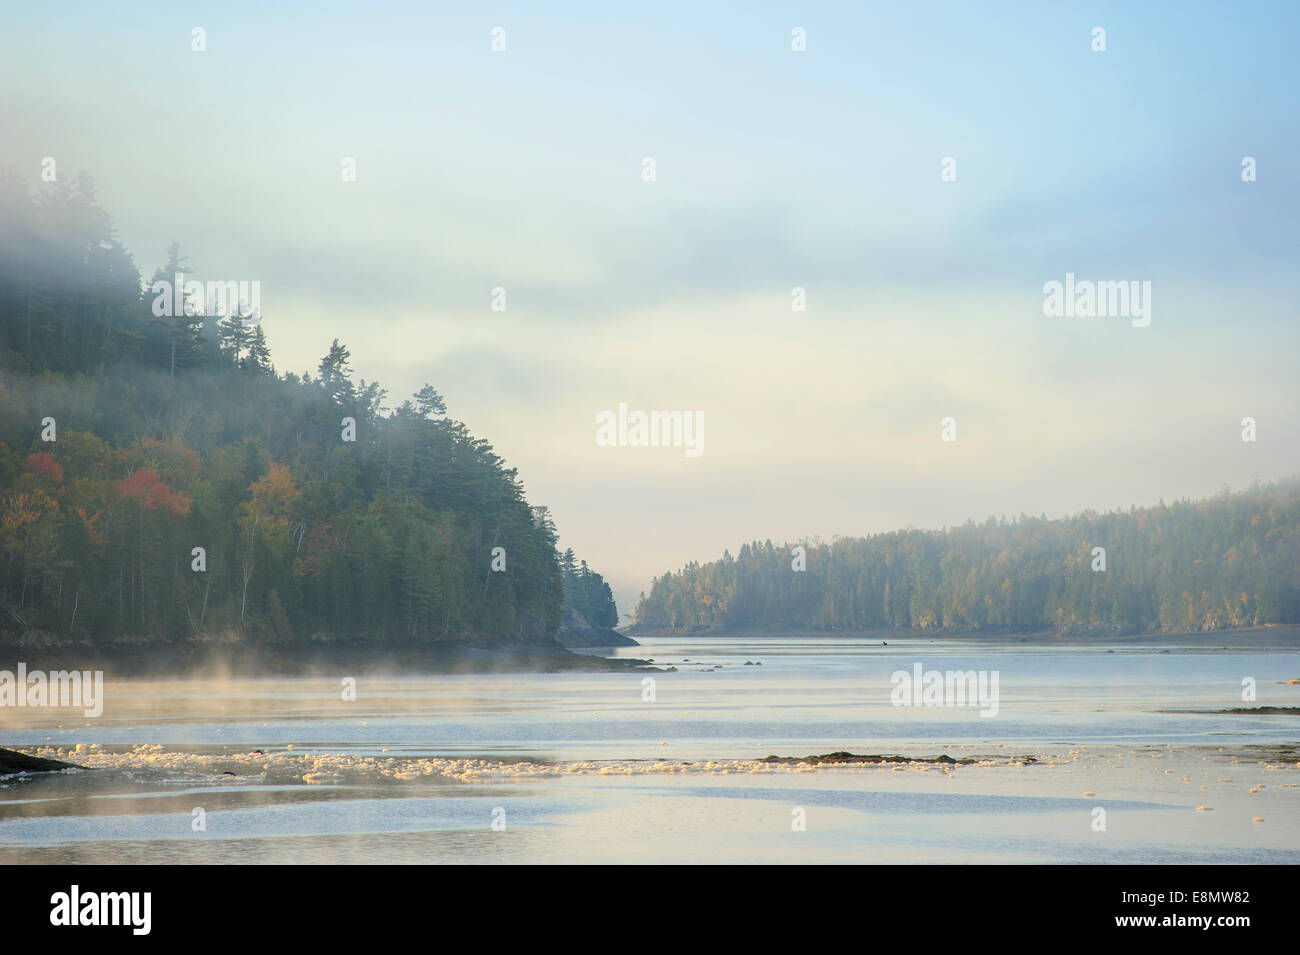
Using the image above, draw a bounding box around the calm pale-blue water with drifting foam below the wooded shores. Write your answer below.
[0,637,1300,864]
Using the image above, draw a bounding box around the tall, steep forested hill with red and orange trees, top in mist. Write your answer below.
[0,174,612,646]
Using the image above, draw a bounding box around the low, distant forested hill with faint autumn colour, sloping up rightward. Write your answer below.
[636,481,1300,634]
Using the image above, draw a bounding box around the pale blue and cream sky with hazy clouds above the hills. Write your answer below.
[0,0,1300,621]
